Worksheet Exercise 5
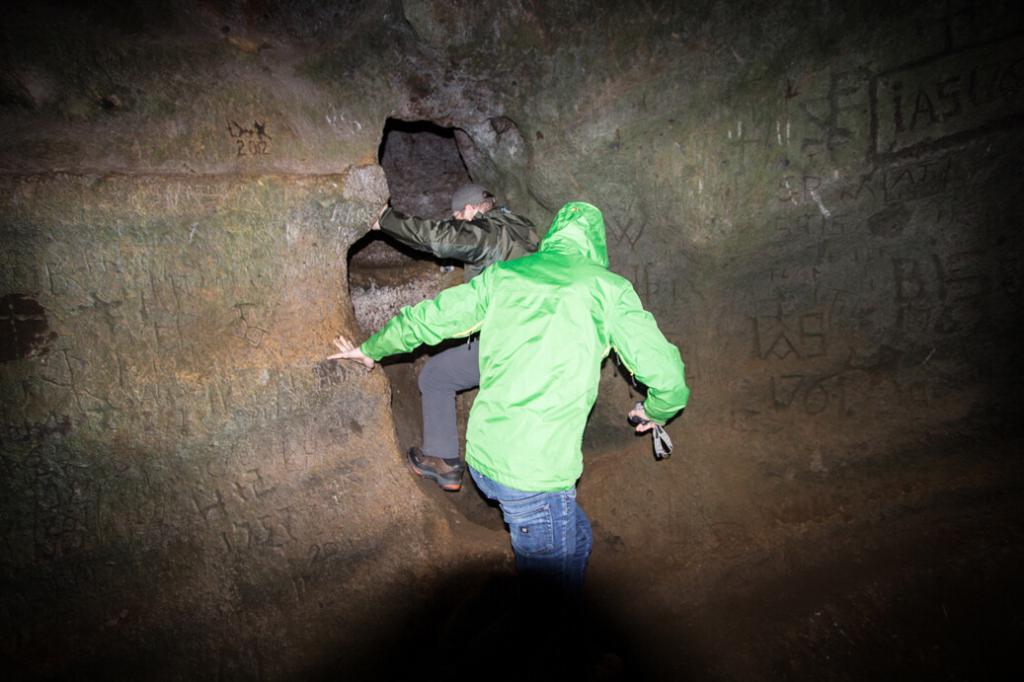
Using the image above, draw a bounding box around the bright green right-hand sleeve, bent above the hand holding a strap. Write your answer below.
[608,285,690,424]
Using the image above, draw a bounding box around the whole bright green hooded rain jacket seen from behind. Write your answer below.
[361,202,690,492]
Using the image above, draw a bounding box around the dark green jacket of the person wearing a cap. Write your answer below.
[380,208,538,282]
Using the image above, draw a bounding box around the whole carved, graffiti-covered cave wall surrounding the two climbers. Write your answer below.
[0,0,1024,677]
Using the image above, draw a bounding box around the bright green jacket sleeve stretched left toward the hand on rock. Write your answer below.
[359,274,489,360]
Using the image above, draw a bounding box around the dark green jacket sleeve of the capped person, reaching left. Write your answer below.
[380,209,502,263]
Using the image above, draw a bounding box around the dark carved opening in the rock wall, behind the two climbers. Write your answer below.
[348,119,502,528]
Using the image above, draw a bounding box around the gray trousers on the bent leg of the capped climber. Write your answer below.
[419,338,480,459]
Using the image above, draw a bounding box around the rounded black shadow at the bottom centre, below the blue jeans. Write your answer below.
[331,572,659,680]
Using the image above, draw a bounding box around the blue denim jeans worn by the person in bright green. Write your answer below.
[469,467,594,600]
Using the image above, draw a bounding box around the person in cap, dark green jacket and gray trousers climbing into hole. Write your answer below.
[373,184,538,492]
